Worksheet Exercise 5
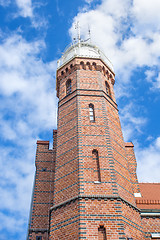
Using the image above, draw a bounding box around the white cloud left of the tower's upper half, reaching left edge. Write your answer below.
[0,35,56,130]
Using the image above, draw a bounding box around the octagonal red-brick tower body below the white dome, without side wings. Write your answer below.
[50,58,143,240]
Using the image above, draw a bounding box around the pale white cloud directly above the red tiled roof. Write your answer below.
[136,137,160,182]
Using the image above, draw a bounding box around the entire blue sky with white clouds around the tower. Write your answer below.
[0,0,160,240]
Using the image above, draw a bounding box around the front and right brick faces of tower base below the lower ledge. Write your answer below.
[79,198,144,240]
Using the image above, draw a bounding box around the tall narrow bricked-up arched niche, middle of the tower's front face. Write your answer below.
[92,149,101,182]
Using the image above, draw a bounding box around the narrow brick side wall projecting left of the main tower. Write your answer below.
[28,141,56,240]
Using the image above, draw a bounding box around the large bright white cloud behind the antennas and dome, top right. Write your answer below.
[70,0,160,86]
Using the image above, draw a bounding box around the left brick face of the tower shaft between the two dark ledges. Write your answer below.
[54,96,78,204]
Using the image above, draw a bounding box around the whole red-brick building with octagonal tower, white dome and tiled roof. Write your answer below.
[28,41,160,240]
